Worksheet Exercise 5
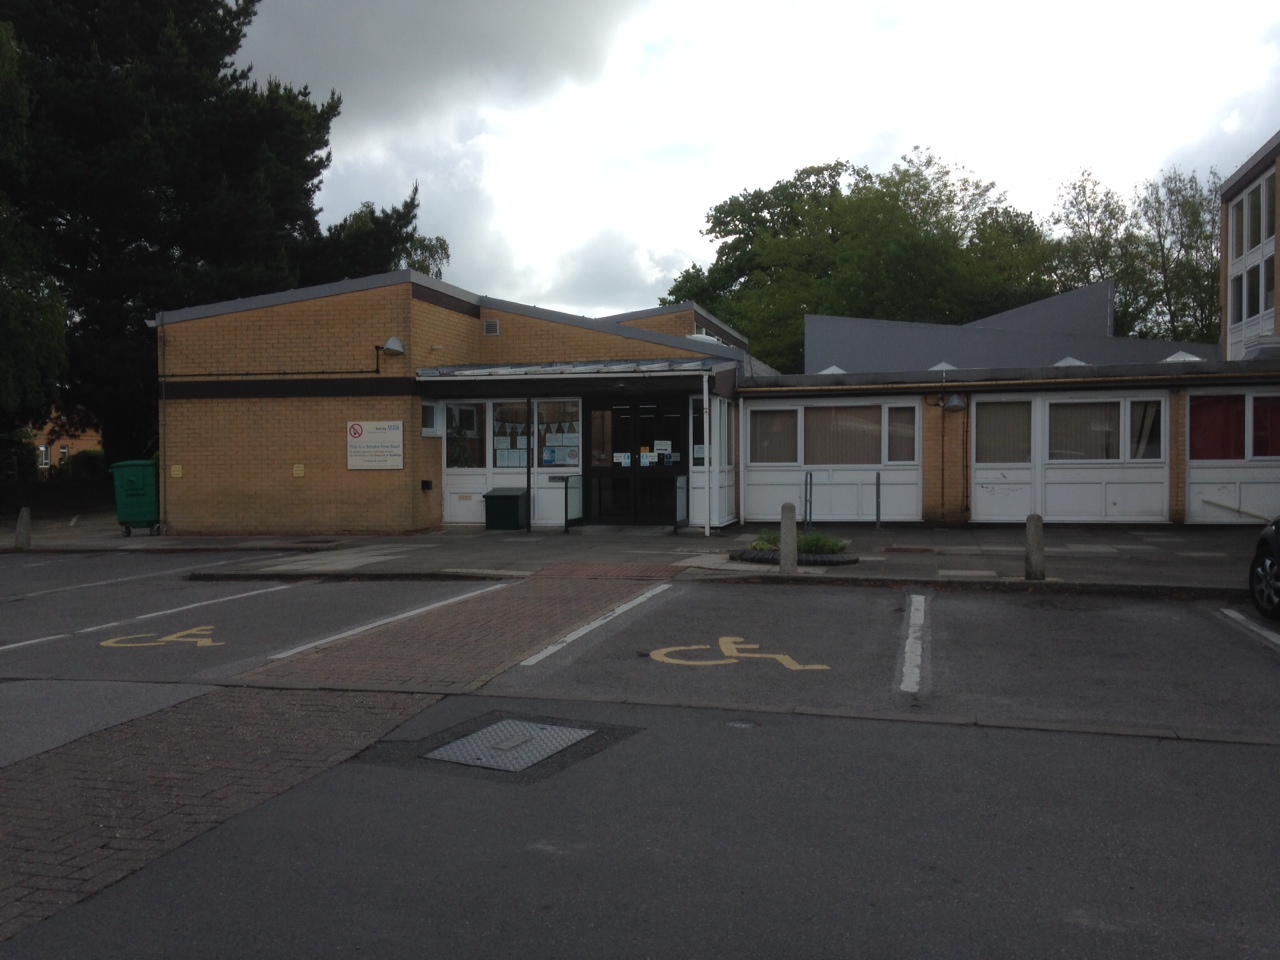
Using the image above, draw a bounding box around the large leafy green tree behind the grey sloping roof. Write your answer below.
[662,148,1052,371]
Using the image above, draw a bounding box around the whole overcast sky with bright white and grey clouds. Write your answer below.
[241,0,1280,316]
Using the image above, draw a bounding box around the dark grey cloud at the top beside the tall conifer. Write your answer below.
[238,0,646,137]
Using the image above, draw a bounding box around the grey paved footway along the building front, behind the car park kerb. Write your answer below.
[7,506,1262,596]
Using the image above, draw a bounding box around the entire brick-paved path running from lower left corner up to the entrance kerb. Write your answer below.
[0,567,675,941]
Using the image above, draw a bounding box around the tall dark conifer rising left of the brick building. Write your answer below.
[0,0,445,460]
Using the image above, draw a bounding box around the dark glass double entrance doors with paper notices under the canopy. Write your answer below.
[582,398,689,525]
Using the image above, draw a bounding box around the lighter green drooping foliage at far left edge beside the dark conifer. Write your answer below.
[0,23,67,434]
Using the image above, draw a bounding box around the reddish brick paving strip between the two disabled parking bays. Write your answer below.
[237,568,666,694]
